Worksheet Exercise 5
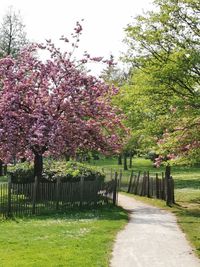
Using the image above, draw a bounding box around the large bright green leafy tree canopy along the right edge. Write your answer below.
[118,0,200,164]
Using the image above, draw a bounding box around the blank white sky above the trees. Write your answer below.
[0,0,152,75]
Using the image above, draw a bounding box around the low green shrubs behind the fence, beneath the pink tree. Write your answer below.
[11,161,104,183]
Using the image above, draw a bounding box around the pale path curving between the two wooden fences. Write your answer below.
[111,194,200,267]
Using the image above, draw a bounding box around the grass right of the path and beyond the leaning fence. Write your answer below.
[90,158,200,257]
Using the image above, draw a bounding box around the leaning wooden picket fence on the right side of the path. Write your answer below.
[127,166,175,205]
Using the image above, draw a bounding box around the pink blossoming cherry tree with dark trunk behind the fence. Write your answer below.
[0,23,123,181]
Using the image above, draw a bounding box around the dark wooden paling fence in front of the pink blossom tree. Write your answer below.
[0,177,118,217]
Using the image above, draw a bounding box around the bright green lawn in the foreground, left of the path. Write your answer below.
[0,205,128,267]
